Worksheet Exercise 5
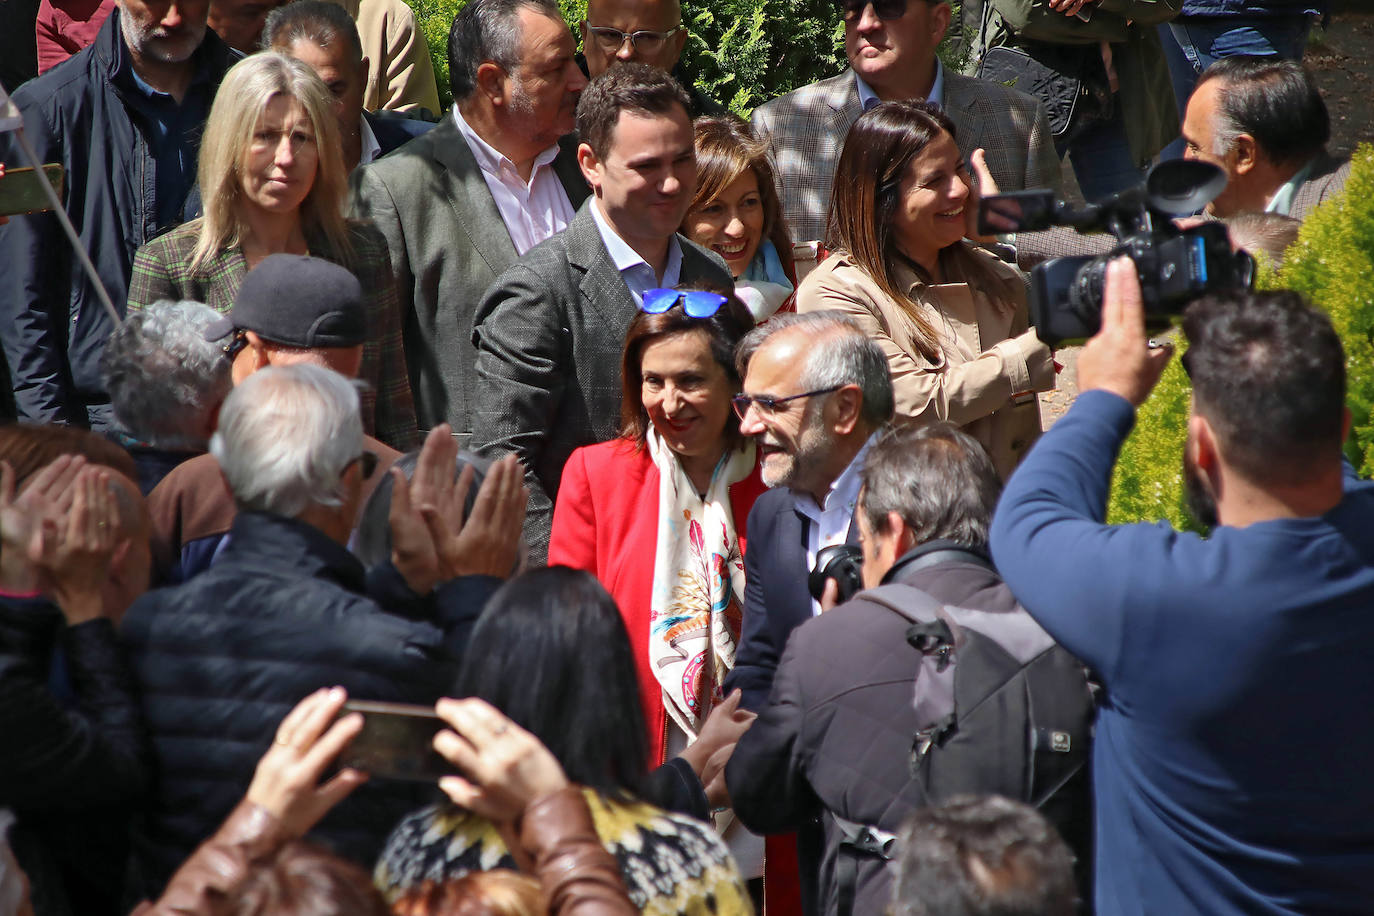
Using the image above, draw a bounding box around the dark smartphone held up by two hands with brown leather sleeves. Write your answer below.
[339,700,460,783]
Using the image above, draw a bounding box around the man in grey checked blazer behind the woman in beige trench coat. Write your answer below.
[753,0,1077,242]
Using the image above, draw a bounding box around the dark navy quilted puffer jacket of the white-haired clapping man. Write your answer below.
[124,512,496,898]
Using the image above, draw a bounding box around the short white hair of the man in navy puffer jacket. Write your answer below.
[210,363,363,518]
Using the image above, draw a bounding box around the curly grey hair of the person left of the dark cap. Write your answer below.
[100,299,232,449]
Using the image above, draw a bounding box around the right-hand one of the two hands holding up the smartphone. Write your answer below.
[434,698,567,824]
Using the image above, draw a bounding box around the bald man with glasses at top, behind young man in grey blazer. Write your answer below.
[581,0,724,118]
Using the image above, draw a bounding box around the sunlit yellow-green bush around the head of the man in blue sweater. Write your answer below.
[1107,146,1374,530]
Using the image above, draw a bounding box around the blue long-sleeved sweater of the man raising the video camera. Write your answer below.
[992,391,1374,916]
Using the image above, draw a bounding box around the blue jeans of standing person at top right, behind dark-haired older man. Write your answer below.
[1160,14,1312,159]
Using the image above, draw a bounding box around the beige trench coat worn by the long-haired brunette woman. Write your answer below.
[797,243,1054,479]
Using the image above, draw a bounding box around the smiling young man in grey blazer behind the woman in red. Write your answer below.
[471,63,734,562]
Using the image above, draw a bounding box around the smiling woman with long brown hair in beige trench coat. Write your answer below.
[797,102,1054,479]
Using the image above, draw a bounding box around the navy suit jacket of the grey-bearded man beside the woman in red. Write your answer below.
[724,486,859,713]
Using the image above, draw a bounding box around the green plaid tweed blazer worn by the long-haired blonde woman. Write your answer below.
[129,220,419,452]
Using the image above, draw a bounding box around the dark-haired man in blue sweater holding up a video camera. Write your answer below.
[992,260,1374,916]
